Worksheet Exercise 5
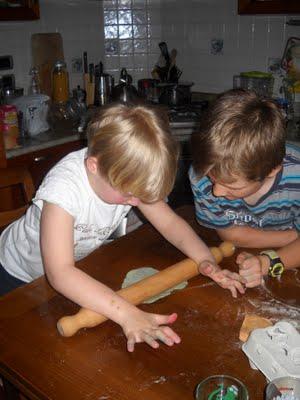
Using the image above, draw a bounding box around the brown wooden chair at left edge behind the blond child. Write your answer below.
[0,167,35,228]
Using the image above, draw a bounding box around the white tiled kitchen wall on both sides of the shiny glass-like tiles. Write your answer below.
[0,0,300,92]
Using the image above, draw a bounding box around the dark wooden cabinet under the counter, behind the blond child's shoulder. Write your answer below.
[7,140,85,189]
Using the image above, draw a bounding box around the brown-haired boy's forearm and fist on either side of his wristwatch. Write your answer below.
[237,234,300,287]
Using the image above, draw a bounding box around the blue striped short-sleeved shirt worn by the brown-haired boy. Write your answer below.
[189,145,300,231]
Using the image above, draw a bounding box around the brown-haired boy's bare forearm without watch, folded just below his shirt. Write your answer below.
[217,226,298,249]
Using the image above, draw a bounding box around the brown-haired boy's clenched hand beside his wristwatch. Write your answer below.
[236,251,269,288]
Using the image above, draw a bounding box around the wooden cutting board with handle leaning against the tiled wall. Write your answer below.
[31,32,65,97]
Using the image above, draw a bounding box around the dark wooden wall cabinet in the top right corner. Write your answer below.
[238,0,300,14]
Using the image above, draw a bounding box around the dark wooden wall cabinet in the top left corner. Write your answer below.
[0,0,40,21]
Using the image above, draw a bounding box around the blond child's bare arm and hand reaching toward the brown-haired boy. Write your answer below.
[138,201,244,297]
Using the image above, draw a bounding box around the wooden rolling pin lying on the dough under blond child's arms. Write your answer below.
[57,242,235,337]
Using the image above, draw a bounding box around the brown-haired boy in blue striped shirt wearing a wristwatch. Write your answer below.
[189,89,300,287]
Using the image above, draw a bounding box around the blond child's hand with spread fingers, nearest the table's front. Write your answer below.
[122,309,181,352]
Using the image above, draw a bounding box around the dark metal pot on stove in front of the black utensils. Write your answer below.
[158,82,194,107]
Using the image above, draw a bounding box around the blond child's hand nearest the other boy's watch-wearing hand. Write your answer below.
[199,260,245,297]
